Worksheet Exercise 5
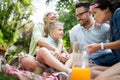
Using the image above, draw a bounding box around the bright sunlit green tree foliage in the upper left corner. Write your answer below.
[0,0,32,47]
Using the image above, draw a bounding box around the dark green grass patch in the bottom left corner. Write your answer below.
[0,72,18,80]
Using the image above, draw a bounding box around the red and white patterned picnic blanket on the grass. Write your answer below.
[3,65,58,80]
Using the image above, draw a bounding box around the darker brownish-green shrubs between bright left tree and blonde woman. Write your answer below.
[6,21,34,65]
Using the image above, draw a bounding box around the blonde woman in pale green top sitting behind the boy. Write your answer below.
[20,12,70,73]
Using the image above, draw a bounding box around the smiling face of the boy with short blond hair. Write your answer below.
[50,25,64,41]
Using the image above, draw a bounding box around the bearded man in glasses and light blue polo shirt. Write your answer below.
[70,2,111,65]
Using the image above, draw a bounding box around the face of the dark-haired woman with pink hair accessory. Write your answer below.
[93,8,107,24]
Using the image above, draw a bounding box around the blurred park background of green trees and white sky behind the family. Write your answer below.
[0,0,93,69]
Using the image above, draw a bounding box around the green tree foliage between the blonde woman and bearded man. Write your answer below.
[46,0,93,50]
